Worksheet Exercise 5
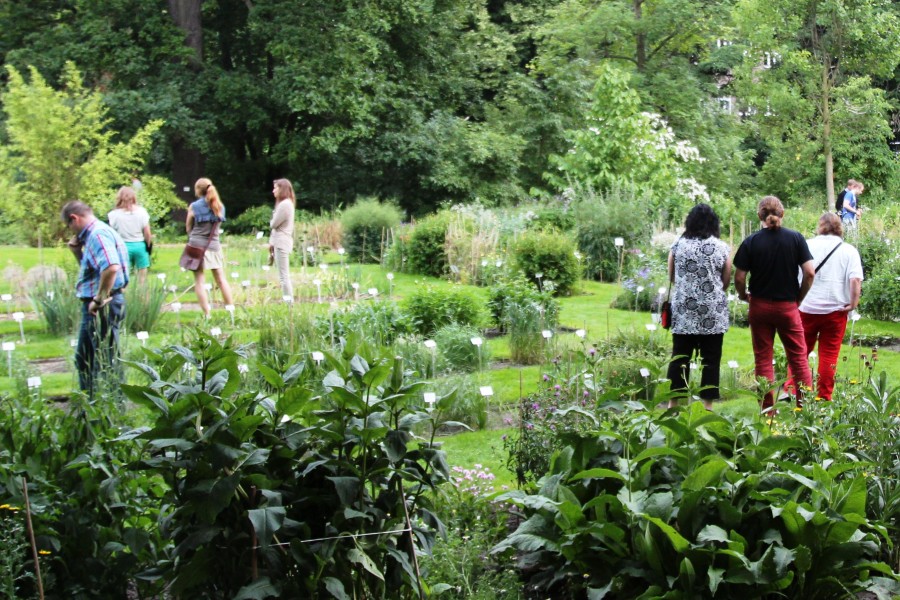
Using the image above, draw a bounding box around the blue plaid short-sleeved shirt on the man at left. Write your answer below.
[75,219,128,298]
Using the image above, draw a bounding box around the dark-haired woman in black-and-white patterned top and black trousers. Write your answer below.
[668,204,731,408]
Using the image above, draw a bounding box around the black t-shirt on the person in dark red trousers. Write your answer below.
[734,227,813,301]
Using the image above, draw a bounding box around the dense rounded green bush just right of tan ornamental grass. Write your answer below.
[515,231,581,296]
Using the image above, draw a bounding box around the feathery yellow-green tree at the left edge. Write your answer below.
[0,63,162,241]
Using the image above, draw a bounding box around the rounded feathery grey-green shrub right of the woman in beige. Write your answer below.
[341,198,402,263]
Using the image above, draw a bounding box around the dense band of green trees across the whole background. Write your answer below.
[0,0,900,219]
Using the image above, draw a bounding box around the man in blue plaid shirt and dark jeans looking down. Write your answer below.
[62,200,128,398]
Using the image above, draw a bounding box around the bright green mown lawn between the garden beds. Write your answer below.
[0,239,900,476]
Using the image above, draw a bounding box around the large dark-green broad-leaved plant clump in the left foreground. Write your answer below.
[123,334,449,598]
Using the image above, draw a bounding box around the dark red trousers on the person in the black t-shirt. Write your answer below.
[748,296,812,408]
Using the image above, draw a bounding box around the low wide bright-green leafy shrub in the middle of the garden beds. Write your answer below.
[403,285,481,335]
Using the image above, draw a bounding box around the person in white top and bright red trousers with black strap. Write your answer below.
[788,212,863,400]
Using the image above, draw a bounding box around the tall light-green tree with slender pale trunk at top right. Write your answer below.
[734,0,900,209]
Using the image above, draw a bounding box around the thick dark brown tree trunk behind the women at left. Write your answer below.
[168,0,205,202]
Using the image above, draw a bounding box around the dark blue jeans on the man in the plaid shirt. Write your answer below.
[75,294,125,398]
